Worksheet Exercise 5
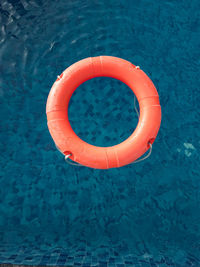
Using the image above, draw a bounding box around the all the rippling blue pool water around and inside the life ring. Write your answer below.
[0,0,200,267]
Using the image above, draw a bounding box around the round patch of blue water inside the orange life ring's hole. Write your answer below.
[68,77,138,147]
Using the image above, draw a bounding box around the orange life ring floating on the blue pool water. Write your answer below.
[46,56,161,169]
